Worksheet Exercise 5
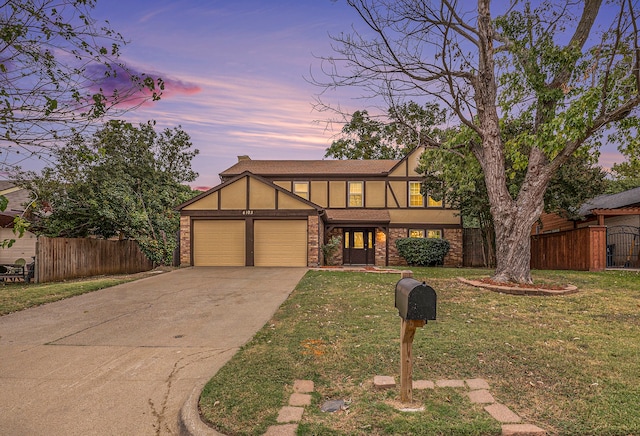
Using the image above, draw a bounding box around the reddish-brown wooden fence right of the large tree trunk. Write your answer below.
[531,226,607,271]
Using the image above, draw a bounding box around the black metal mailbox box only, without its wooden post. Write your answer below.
[396,278,436,321]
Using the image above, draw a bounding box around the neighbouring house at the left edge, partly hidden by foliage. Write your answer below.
[0,180,37,264]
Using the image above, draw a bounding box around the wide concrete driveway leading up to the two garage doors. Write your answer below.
[0,267,306,436]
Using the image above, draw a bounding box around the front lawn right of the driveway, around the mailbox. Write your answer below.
[200,268,640,435]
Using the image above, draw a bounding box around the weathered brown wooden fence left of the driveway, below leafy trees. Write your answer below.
[36,236,153,283]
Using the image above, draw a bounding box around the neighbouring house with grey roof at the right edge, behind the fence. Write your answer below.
[532,187,640,268]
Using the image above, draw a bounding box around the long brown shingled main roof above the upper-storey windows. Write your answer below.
[220,159,399,179]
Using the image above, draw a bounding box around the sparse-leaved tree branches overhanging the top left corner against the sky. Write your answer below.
[0,0,164,169]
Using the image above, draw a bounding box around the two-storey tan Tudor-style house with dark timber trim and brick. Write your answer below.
[178,149,462,266]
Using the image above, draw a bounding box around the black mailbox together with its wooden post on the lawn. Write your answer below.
[395,271,436,403]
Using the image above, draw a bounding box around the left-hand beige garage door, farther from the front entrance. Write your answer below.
[193,220,246,266]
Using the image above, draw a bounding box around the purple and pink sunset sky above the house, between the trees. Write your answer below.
[8,0,622,188]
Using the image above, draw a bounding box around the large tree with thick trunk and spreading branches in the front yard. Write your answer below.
[316,0,640,283]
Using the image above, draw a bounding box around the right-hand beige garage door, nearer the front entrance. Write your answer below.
[253,220,307,266]
